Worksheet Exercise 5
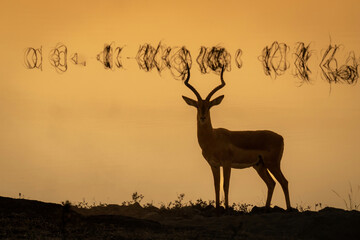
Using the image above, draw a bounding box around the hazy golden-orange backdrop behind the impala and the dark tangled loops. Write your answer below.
[0,0,360,207]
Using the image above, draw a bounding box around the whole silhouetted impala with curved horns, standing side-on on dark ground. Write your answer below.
[182,66,291,210]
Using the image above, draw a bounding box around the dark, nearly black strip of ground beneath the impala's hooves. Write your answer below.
[0,197,360,240]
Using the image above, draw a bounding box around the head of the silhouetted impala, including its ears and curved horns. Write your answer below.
[182,66,225,124]
